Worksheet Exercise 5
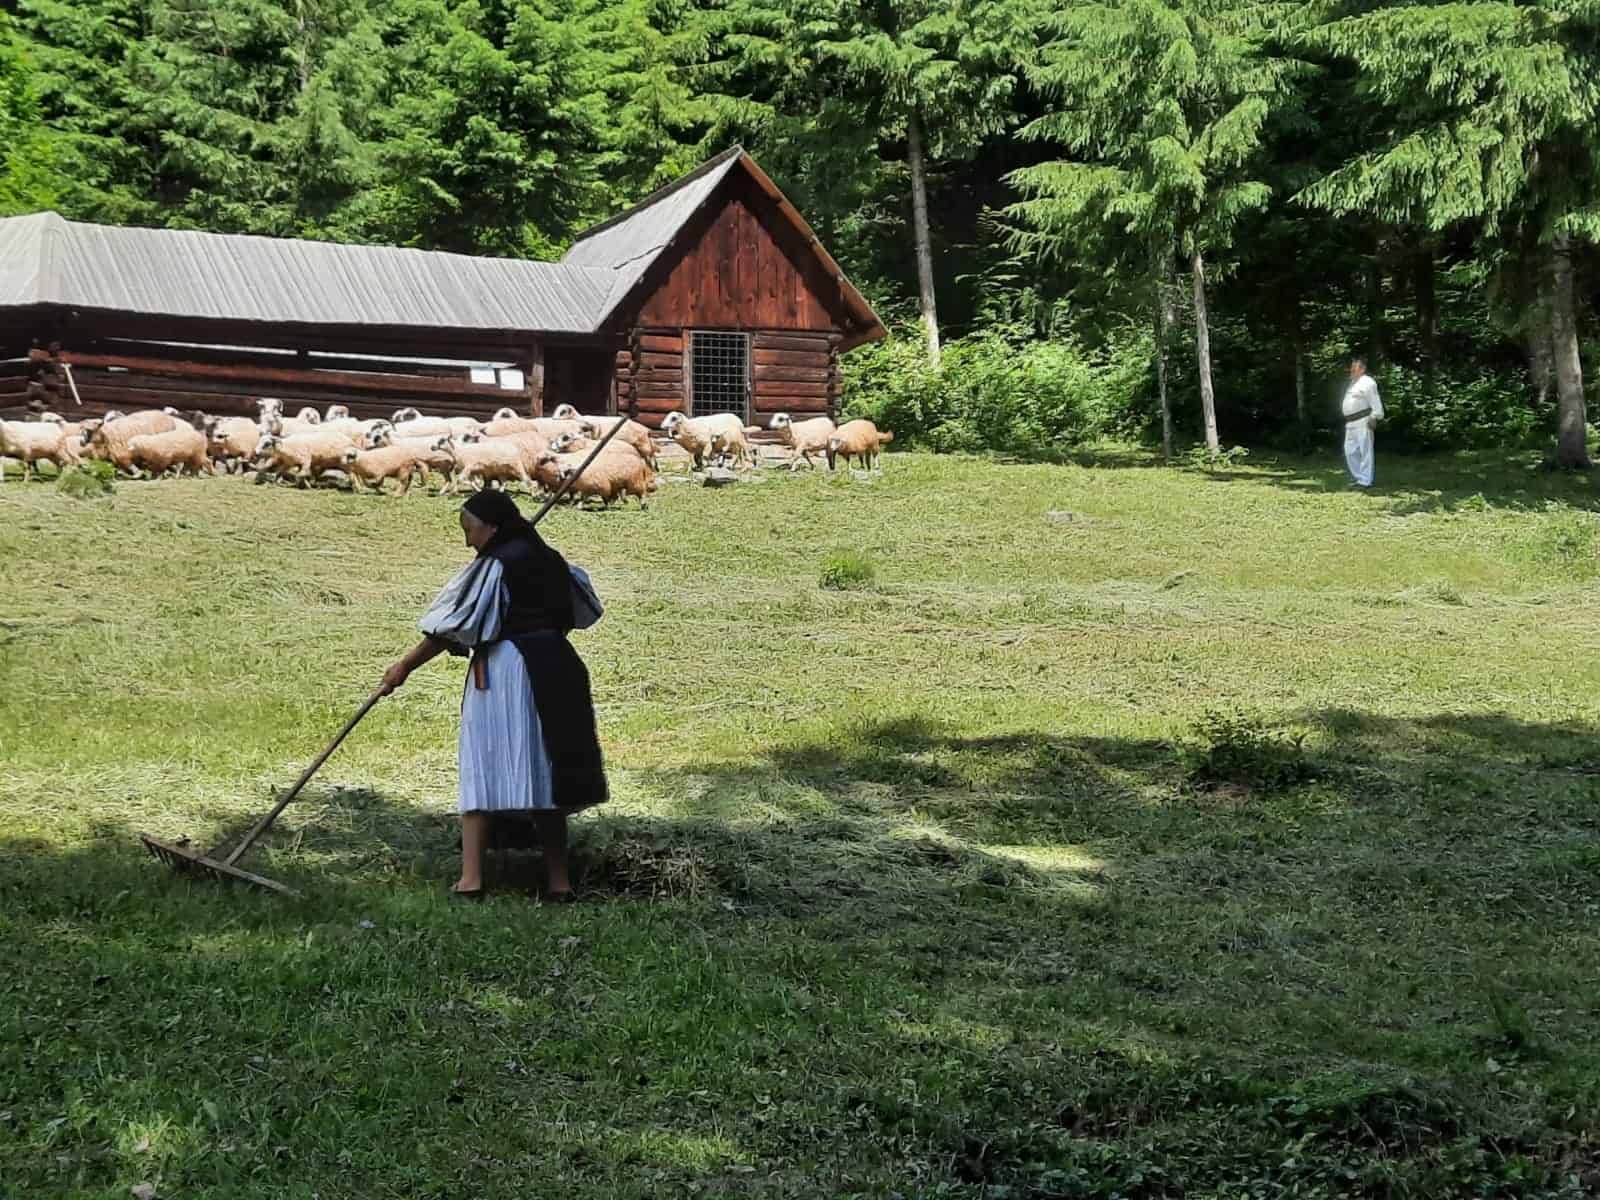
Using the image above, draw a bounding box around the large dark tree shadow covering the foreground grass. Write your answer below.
[0,710,1600,1197]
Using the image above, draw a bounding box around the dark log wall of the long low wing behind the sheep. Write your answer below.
[20,342,542,418]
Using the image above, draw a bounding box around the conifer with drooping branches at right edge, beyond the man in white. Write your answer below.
[1301,0,1600,467]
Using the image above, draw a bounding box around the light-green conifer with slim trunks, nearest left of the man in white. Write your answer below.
[1010,0,1294,453]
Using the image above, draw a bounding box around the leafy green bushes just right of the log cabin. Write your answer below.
[846,326,1150,454]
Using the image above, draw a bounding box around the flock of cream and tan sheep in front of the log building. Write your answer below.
[0,400,894,507]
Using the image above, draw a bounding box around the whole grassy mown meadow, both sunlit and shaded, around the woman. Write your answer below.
[0,451,1600,1200]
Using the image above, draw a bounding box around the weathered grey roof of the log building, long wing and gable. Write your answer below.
[0,146,883,344]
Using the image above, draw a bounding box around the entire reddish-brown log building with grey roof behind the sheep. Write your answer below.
[0,146,883,427]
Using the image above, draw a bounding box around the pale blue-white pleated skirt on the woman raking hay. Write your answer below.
[459,642,555,813]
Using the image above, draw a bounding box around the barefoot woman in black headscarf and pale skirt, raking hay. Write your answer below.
[382,490,606,899]
